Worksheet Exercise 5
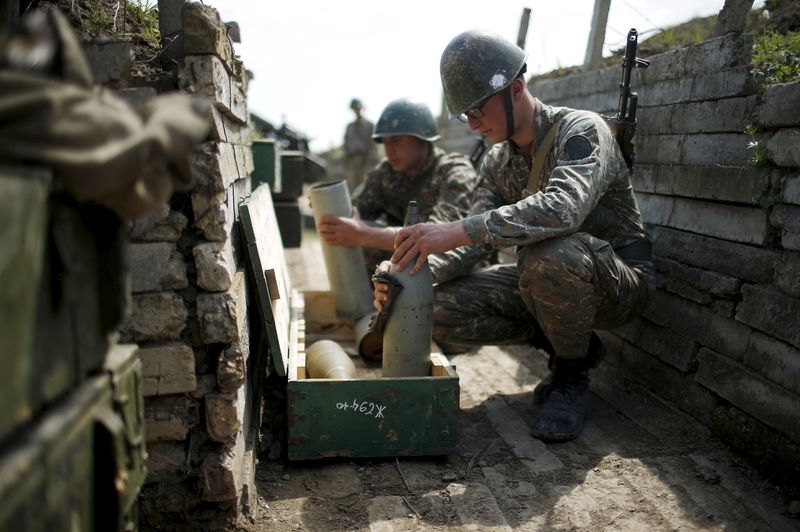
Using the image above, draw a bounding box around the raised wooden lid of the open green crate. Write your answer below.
[239,185,291,376]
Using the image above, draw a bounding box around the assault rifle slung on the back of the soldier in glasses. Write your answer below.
[611,28,650,172]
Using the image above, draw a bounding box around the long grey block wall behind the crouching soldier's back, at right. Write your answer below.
[438,33,800,478]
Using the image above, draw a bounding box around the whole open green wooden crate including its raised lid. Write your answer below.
[240,187,459,460]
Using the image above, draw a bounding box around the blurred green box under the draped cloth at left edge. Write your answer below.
[0,164,130,440]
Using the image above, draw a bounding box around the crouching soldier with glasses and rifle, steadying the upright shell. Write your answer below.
[375,31,654,441]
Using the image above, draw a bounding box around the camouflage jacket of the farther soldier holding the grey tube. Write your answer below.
[353,147,478,227]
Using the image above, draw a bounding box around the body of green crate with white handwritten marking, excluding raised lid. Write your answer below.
[287,292,459,460]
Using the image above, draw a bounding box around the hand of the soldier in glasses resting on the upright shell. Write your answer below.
[391,220,471,275]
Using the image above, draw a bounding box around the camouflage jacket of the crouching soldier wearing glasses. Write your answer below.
[432,100,647,282]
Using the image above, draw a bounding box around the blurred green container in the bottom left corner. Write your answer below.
[0,344,147,531]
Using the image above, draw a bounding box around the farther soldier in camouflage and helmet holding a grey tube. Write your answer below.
[317,99,477,272]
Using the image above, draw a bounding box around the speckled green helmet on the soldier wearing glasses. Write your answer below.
[439,30,525,118]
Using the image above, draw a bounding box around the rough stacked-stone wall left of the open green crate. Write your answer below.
[91,2,265,529]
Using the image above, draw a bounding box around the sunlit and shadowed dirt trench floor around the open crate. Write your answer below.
[239,227,800,532]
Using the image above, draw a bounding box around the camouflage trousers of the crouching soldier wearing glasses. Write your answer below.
[433,233,653,359]
